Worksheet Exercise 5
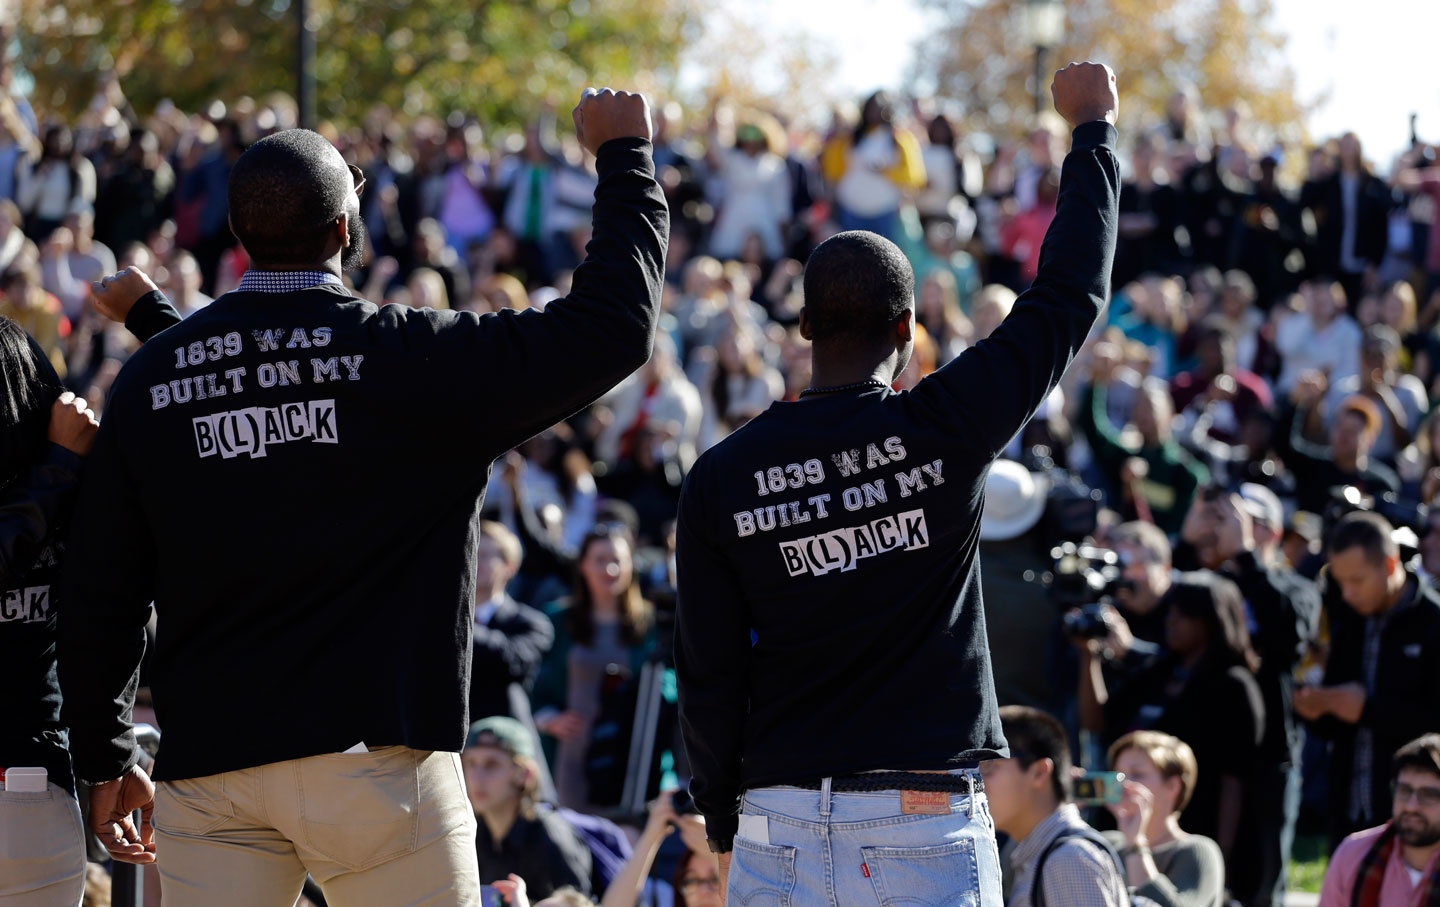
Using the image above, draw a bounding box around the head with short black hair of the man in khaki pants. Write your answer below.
[229,130,350,265]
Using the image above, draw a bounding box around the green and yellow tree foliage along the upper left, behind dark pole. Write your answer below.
[17,0,697,125]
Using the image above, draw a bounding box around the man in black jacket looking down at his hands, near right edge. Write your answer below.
[1295,513,1440,842]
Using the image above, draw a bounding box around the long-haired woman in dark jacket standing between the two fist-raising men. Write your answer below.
[533,525,655,812]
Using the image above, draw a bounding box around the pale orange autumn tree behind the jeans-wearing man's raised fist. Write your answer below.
[916,0,1305,141]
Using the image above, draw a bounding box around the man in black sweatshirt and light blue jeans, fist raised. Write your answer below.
[675,63,1120,906]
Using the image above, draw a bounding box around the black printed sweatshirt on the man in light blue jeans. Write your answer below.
[675,122,1120,841]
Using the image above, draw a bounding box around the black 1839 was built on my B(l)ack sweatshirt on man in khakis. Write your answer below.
[60,138,670,780]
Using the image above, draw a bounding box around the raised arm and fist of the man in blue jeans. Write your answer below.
[914,63,1120,452]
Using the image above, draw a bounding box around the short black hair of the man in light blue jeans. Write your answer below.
[805,230,914,341]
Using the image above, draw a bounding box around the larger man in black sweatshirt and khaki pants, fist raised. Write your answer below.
[59,89,670,906]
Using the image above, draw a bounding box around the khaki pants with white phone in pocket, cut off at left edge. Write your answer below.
[0,783,85,907]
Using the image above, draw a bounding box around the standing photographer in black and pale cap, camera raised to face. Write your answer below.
[1175,484,1320,904]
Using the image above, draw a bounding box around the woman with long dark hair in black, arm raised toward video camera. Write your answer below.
[1080,570,1264,890]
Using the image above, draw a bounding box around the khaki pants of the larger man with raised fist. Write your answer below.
[154,746,480,907]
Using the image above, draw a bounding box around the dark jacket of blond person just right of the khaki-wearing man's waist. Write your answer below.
[469,596,554,724]
